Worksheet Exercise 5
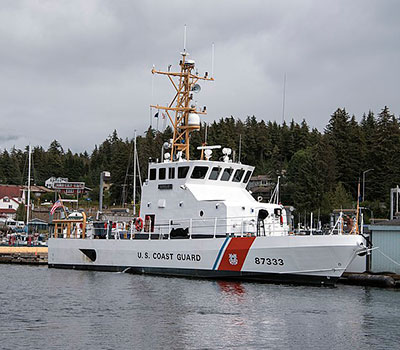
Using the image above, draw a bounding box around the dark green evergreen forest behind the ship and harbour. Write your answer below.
[0,107,400,223]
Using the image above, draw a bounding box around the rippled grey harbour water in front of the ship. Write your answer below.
[0,265,400,350]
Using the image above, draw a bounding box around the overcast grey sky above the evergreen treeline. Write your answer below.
[0,0,400,152]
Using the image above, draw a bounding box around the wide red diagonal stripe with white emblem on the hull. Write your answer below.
[218,237,256,271]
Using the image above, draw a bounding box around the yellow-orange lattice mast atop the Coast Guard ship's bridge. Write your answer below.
[151,50,214,161]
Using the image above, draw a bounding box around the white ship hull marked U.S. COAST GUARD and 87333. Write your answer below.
[48,235,362,285]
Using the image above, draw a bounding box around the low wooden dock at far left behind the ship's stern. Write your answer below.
[0,246,48,265]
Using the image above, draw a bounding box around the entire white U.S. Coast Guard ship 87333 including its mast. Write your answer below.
[48,45,366,285]
